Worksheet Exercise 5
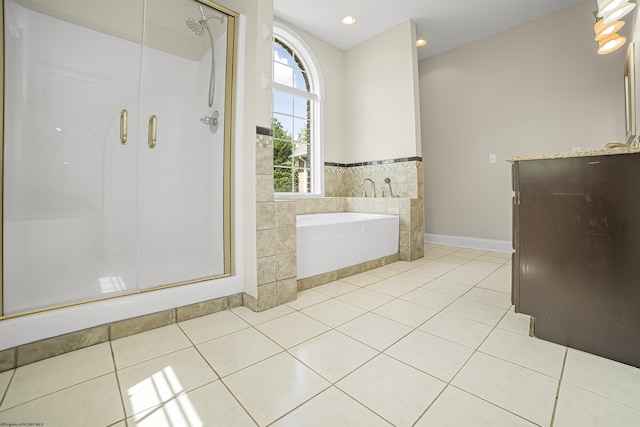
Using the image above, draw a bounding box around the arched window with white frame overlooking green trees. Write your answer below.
[272,24,323,195]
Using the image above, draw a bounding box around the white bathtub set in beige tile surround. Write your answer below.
[296,212,400,279]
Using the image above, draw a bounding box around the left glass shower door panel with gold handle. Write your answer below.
[3,0,143,315]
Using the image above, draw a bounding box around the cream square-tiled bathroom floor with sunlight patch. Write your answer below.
[0,245,640,427]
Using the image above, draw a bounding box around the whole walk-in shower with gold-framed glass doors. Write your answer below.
[0,0,237,318]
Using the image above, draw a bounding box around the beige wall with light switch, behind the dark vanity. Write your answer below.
[419,1,626,241]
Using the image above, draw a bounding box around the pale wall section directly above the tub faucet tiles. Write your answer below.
[344,21,420,163]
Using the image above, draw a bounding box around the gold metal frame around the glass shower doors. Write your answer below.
[0,0,240,321]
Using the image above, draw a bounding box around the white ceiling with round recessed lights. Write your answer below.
[273,0,597,60]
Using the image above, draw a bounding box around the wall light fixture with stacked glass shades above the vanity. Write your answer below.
[593,0,636,55]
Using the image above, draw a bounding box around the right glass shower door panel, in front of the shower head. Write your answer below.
[139,0,228,289]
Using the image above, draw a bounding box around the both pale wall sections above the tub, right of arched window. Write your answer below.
[276,19,421,163]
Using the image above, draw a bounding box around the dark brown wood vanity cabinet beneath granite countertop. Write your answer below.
[512,153,640,367]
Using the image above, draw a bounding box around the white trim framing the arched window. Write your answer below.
[271,22,324,198]
